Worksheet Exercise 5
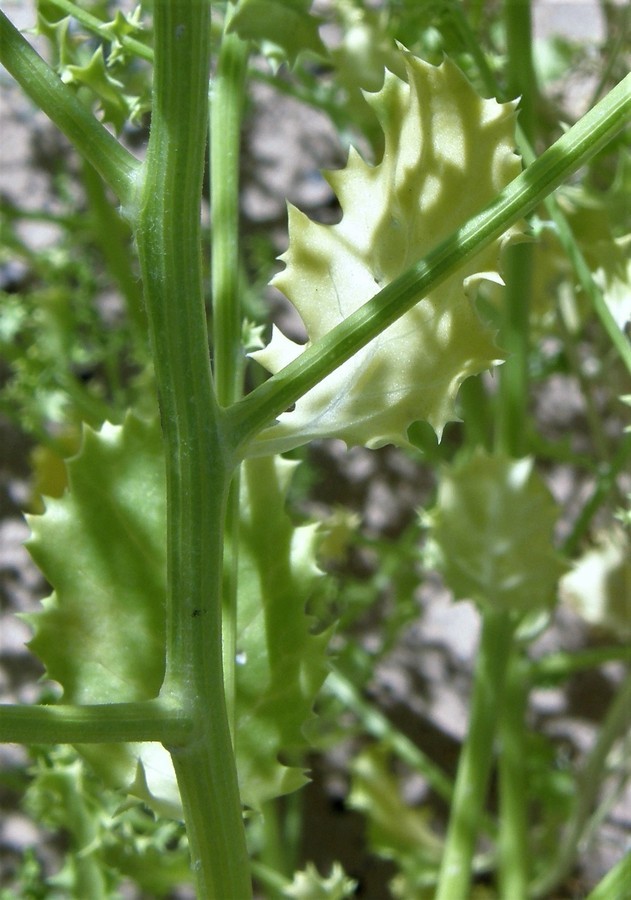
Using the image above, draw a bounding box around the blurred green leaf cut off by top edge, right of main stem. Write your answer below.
[228,0,327,67]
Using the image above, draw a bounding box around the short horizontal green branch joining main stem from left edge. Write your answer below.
[0,700,192,746]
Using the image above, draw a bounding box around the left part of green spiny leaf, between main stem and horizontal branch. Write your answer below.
[28,417,166,703]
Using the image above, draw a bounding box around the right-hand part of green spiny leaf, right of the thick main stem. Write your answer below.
[237,457,329,807]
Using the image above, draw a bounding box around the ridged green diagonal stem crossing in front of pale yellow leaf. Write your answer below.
[228,75,631,454]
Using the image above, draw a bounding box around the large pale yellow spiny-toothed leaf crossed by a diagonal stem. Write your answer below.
[251,49,520,453]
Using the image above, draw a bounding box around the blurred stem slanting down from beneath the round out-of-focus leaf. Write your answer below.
[434,610,514,900]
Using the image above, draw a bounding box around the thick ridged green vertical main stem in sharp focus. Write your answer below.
[135,0,251,900]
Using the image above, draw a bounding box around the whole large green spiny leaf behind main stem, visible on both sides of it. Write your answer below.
[26,416,329,817]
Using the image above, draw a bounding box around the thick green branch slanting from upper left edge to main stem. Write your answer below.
[0,11,140,211]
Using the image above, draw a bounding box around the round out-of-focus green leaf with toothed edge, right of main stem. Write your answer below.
[427,451,567,613]
